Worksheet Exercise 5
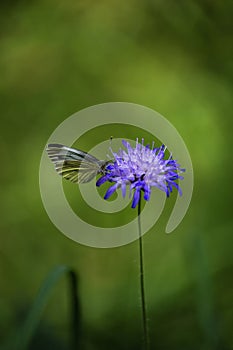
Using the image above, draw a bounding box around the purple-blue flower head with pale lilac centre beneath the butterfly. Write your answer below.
[96,139,185,208]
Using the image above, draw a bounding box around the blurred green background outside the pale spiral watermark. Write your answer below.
[0,0,233,350]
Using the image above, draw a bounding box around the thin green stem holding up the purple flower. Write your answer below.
[138,195,149,350]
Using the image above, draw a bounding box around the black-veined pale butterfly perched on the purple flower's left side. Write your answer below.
[46,143,110,183]
